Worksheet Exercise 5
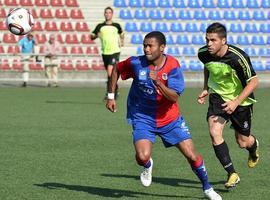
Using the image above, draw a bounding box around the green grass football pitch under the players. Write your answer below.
[0,87,270,200]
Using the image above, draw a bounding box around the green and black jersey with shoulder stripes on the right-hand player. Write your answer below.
[198,45,257,106]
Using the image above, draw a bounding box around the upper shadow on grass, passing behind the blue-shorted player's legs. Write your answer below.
[101,174,228,192]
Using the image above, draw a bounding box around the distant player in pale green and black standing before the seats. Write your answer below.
[91,7,124,97]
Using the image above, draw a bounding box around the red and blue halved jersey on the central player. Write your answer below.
[117,55,184,127]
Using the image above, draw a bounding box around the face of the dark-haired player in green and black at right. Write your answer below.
[206,33,226,55]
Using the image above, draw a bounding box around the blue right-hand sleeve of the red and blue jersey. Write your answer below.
[168,67,185,95]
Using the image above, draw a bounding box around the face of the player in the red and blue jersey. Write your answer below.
[143,38,165,61]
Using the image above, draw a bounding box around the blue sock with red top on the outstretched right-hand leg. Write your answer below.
[190,156,212,190]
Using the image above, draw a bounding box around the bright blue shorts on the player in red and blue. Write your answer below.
[133,116,191,147]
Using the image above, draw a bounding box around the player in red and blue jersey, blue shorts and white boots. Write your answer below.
[106,31,222,200]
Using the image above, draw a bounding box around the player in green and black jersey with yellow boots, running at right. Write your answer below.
[198,23,259,188]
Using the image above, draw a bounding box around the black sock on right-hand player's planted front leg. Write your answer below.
[213,141,235,174]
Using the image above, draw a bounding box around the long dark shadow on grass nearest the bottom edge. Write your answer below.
[34,183,200,199]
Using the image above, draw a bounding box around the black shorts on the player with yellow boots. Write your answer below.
[207,93,253,136]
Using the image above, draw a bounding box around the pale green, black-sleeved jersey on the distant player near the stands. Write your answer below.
[92,22,123,55]
